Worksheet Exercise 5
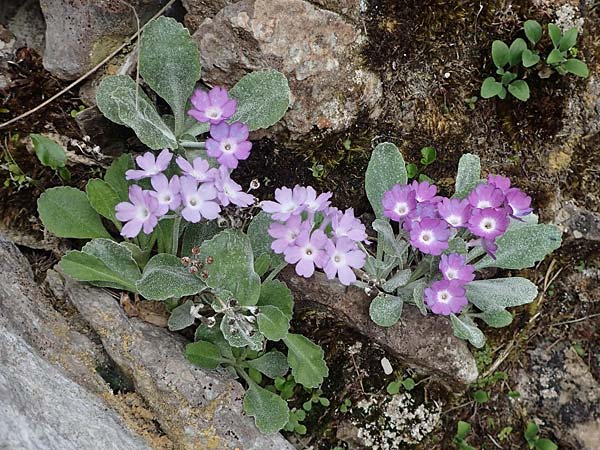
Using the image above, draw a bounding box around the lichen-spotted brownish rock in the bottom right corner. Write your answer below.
[516,342,600,450]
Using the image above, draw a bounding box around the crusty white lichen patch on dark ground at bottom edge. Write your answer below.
[353,392,441,450]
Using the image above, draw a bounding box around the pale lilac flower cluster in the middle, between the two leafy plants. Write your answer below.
[261,185,367,286]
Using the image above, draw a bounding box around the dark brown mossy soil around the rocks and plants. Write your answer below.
[0,0,600,450]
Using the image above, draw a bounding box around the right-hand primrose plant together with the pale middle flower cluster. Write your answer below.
[255,143,561,347]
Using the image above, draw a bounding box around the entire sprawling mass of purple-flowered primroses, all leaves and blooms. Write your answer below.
[38,14,560,433]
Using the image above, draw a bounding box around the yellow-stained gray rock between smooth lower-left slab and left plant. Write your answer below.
[55,279,293,450]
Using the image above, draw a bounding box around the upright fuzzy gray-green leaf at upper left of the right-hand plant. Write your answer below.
[365,142,407,218]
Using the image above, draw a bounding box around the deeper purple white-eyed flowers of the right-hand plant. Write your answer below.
[382,175,532,315]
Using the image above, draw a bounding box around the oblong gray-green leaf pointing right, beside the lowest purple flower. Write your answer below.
[466,277,537,311]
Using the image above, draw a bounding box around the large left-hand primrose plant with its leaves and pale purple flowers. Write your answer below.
[38,18,328,433]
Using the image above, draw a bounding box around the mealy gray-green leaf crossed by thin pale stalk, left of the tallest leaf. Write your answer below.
[96,75,177,150]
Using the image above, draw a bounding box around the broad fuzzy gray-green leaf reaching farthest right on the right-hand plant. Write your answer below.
[475,224,562,270]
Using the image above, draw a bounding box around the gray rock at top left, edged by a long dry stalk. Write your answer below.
[40,0,167,80]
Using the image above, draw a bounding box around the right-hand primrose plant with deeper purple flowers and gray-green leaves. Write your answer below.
[355,143,561,347]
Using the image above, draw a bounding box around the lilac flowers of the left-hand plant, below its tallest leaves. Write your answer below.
[115,87,255,238]
